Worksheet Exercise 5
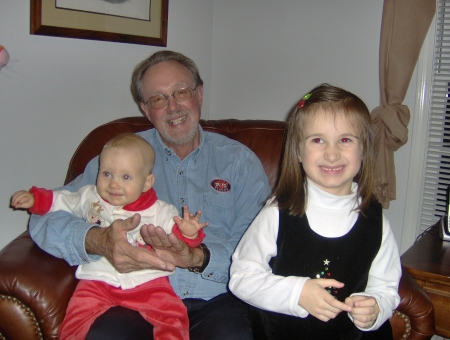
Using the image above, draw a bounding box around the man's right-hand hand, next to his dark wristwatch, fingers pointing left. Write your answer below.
[141,224,204,268]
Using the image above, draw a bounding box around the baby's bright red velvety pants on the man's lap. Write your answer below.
[59,277,189,340]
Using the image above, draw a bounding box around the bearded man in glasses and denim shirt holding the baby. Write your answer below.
[30,51,270,340]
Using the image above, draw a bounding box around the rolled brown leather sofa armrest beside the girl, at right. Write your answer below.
[390,268,435,340]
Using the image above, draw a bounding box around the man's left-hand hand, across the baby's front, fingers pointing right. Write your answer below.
[85,214,175,273]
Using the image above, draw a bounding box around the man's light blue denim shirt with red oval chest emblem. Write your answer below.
[30,128,270,299]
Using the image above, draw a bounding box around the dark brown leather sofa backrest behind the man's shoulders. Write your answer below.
[65,117,285,188]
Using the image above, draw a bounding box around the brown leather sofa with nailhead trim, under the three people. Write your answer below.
[0,117,434,340]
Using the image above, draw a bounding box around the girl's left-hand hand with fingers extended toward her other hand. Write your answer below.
[298,279,352,322]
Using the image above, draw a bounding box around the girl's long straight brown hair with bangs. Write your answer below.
[272,84,375,216]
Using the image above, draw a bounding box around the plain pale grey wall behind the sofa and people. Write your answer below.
[0,0,416,252]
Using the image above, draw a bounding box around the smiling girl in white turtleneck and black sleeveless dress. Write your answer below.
[230,84,401,339]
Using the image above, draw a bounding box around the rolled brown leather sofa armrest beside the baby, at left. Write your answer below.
[0,231,78,340]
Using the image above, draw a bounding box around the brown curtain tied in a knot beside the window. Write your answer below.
[372,0,436,209]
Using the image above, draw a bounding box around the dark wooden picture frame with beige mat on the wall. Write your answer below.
[30,0,169,47]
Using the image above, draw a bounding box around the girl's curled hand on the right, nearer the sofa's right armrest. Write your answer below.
[345,295,380,328]
